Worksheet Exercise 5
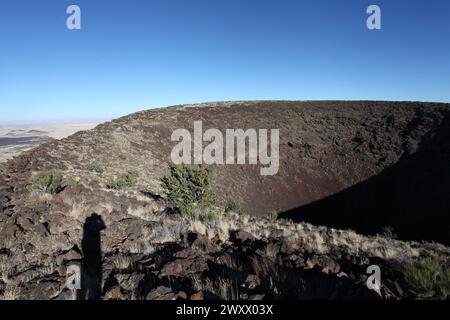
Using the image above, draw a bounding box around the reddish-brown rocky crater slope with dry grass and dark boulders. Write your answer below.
[0,101,450,299]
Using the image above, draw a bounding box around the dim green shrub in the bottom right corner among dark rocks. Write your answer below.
[401,258,450,299]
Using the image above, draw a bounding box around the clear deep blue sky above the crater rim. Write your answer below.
[0,0,450,122]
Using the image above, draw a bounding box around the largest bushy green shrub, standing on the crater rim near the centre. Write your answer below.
[161,165,219,221]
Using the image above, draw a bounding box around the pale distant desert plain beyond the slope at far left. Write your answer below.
[0,121,103,163]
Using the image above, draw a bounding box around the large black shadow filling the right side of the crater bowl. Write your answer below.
[280,110,450,245]
